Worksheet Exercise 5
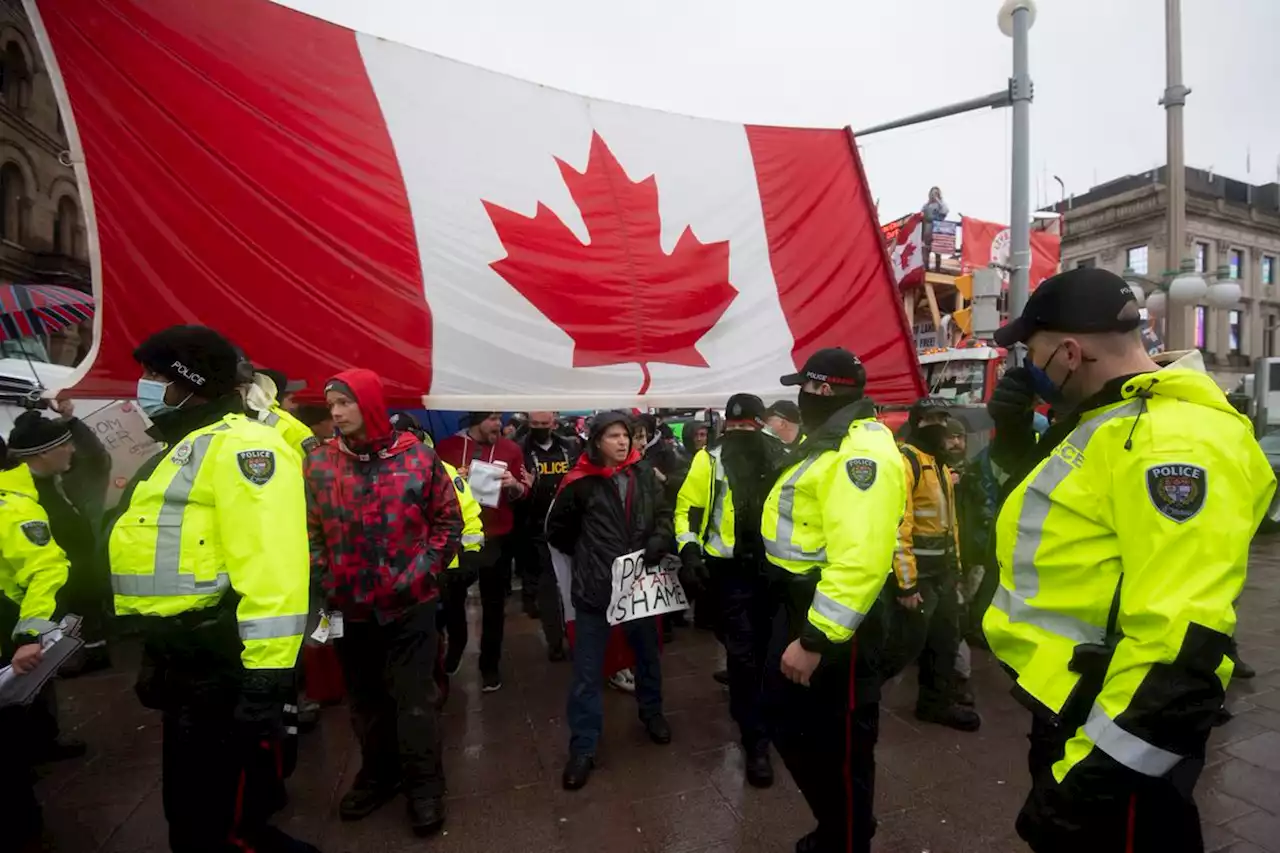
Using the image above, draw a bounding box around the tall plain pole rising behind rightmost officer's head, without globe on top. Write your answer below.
[1160,0,1192,350]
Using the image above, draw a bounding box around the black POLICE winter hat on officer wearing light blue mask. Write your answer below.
[133,325,241,400]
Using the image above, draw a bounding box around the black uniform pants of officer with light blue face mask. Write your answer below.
[136,608,287,853]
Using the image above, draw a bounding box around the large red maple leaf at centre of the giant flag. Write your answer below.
[484,132,737,394]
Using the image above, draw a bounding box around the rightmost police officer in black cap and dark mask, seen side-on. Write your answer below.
[983,269,1275,853]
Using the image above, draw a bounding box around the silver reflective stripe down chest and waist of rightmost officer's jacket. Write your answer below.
[993,400,1142,643]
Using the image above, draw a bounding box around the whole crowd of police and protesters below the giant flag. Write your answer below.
[0,270,1275,853]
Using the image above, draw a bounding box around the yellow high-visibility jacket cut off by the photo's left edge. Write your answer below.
[0,465,68,637]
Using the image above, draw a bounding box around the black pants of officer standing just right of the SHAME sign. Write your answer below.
[707,557,773,749]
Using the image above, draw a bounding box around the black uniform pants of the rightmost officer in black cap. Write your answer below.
[1018,717,1204,853]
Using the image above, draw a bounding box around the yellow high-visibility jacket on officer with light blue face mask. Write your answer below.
[109,414,310,670]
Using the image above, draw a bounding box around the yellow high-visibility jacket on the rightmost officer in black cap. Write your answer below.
[983,353,1275,783]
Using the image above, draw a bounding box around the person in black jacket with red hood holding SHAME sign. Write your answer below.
[547,412,672,790]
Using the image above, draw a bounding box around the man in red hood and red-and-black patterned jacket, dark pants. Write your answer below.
[305,369,463,835]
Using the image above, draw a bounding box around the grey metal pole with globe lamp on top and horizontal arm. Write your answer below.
[1009,4,1032,325]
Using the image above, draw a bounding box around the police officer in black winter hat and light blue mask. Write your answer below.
[109,325,315,853]
